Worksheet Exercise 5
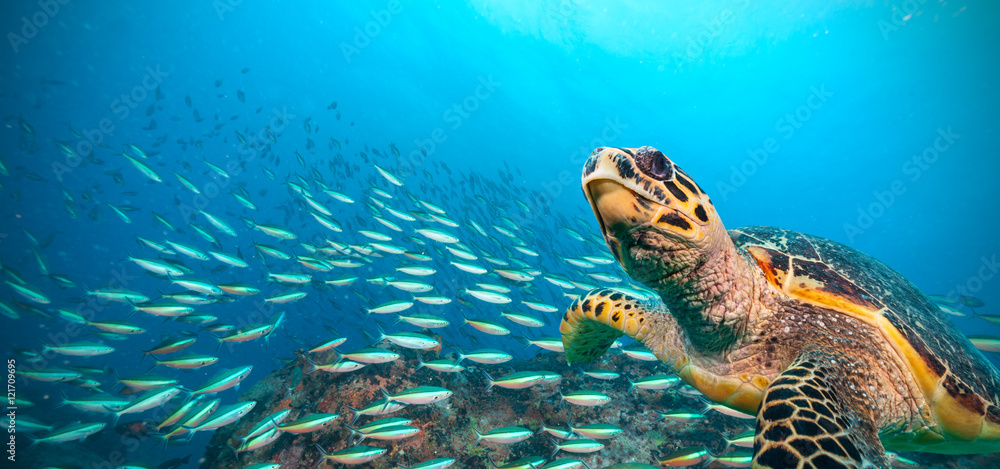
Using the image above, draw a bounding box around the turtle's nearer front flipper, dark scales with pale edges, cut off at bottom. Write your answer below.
[753,349,889,469]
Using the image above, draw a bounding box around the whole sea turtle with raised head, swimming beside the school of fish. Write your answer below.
[559,147,1000,468]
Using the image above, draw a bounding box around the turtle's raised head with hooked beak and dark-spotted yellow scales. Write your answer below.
[583,147,731,285]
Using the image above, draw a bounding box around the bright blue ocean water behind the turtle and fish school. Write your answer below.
[0,0,1000,462]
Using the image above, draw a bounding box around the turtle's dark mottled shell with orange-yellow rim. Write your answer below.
[730,226,1000,452]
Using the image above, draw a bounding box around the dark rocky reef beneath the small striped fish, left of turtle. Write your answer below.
[201,349,1000,469]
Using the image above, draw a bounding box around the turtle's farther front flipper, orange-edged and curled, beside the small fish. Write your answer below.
[559,288,670,363]
